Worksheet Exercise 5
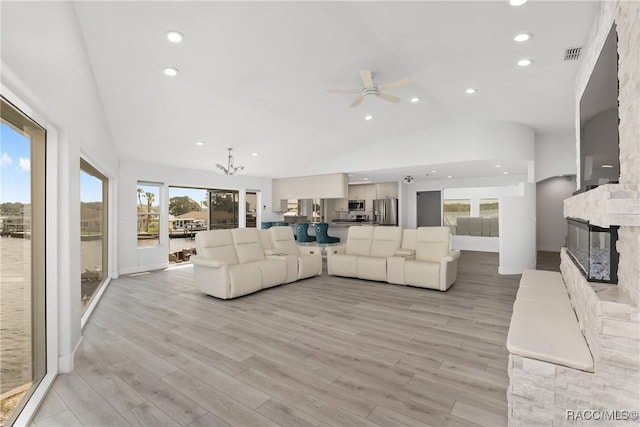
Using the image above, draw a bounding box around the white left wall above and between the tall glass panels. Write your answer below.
[0,2,118,382]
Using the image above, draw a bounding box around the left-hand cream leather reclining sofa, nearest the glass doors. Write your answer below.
[191,227,321,299]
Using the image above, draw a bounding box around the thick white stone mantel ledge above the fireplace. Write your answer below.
[564,184,640,231]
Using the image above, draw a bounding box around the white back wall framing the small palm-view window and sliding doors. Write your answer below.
[117,161,274,274]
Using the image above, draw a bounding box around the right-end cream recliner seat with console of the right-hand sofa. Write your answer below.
[387,227,460,291]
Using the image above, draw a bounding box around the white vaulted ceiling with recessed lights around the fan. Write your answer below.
[75,1,598,180]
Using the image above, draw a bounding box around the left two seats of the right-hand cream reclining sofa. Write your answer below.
[327,225,402,282]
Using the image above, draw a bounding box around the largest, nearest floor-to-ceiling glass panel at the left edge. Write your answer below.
[0,98,47,425]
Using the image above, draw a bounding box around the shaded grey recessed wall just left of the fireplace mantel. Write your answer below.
[536,175,576,252]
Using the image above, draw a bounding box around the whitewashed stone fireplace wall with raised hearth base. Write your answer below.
[508,0,640,426]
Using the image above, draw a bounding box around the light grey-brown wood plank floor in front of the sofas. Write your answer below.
[33,252,556,427]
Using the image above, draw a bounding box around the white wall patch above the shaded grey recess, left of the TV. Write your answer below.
[536,133,576,182]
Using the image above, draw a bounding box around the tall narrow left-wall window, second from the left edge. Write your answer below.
[80,159,109,313]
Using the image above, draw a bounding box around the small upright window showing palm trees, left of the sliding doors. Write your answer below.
[138,182,160,248]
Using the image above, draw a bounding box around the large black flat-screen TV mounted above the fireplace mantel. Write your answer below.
[579,24,620,192]
